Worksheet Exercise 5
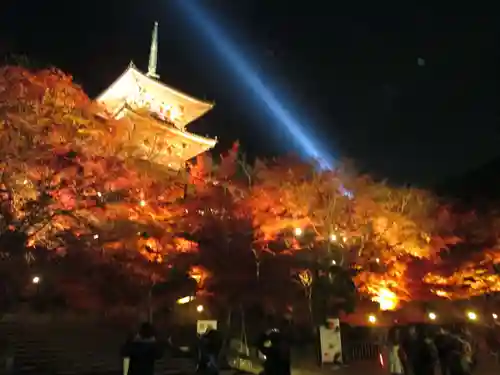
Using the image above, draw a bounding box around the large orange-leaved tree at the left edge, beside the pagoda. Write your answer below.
[0,67,184,312]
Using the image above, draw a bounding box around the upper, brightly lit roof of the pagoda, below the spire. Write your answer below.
[96,63,214,129]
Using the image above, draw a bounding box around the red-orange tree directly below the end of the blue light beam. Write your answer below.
[251,158,362,323]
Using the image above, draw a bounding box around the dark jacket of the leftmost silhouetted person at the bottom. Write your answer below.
[122,336,163,375]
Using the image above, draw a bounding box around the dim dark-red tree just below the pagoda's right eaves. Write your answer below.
[182,145,257,308]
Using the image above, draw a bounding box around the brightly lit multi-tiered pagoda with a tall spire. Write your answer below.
[96,22,217,170]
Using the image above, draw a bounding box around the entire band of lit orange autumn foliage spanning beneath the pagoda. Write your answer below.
[0,67,500,314]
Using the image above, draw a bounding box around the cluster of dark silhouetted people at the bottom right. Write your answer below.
[387,326,478,375]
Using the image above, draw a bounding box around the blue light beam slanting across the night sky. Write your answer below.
[177,0,333,169]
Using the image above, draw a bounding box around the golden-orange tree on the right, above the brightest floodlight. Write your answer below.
[353,177,458,301]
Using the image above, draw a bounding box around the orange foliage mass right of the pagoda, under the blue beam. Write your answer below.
[180,149,472,312]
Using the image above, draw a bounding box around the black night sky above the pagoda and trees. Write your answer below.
[0,0,500,184]
